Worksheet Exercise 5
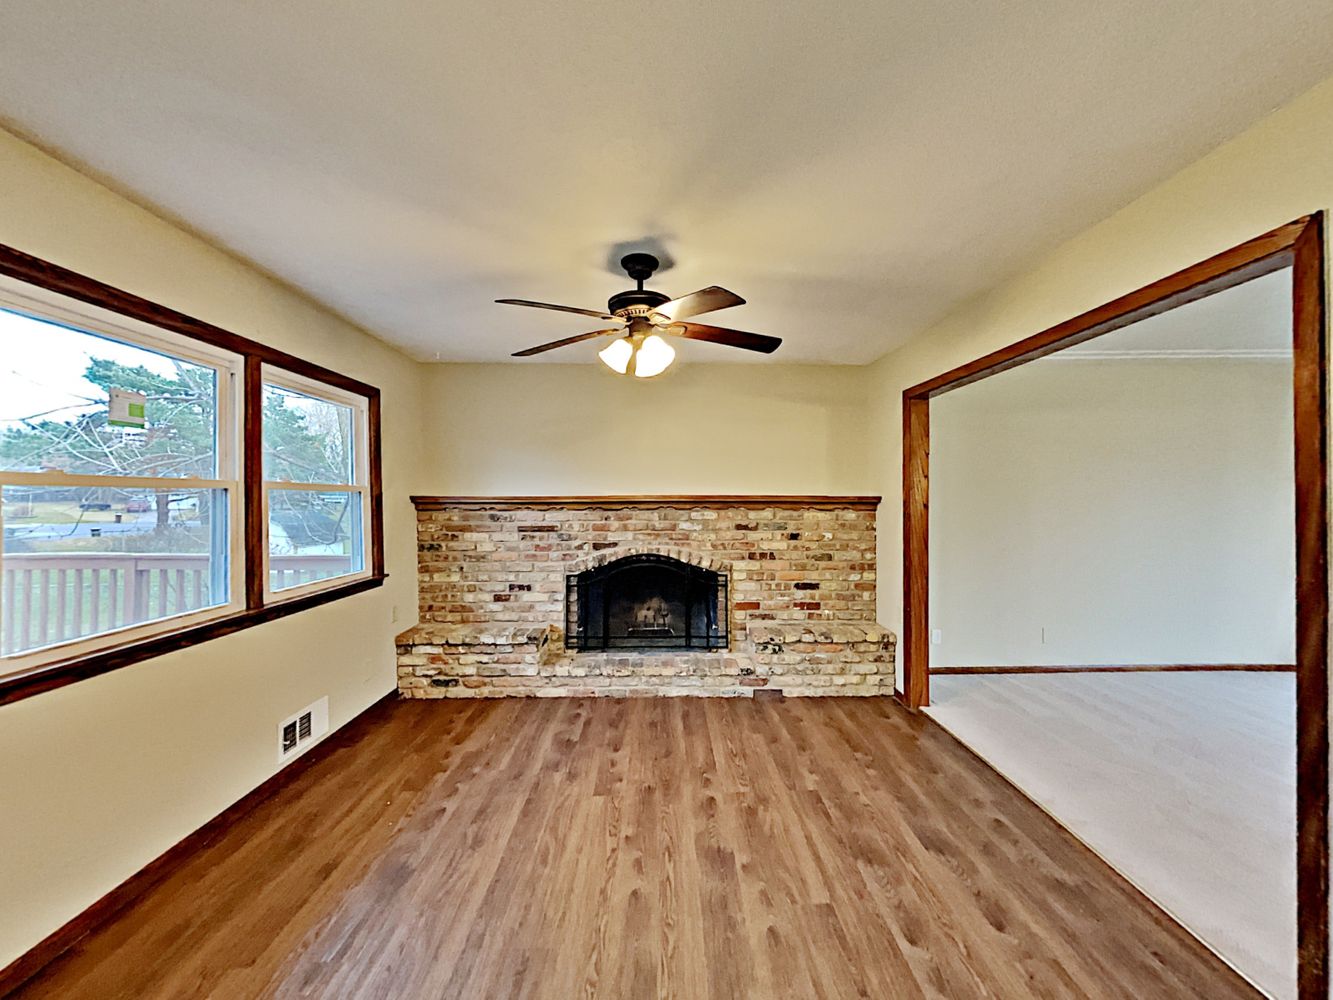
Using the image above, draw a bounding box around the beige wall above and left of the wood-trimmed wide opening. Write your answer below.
[870,80,1333,645]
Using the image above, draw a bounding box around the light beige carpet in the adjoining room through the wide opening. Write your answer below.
[928,673,1296,1000]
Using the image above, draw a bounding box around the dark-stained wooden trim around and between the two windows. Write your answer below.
[0,244,387,705]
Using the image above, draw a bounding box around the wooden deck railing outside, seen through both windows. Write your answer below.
[0,552,349,655]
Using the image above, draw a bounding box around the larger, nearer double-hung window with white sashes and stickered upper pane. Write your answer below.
[0,281,243,673]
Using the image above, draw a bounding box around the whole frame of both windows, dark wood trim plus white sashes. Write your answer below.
[0,244,385,705]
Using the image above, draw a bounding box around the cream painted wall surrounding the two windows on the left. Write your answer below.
[0,125,421,967]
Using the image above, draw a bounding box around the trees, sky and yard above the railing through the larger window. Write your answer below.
[0,312,217,552]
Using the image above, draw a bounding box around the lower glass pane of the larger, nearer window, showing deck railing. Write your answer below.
[0,485,228,656]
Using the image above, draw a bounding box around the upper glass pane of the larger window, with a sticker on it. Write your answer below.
[0,309,219,479]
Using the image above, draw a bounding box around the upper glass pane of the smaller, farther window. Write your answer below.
[264,383,356,484]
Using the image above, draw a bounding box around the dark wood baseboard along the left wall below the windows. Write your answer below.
[0,691,397,999]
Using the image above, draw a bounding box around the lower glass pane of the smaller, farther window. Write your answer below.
[268,489,365,591]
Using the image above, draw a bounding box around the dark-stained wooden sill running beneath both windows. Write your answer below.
[0,575,388,705]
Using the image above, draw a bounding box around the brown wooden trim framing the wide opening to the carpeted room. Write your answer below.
[898,211,1329,1000]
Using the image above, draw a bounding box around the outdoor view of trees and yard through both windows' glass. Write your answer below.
[0,309,363,653]
